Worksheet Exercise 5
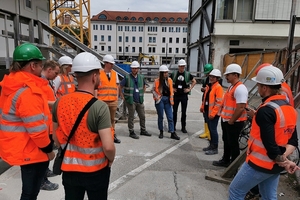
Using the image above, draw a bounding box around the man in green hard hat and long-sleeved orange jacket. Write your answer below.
[0,43,55,200]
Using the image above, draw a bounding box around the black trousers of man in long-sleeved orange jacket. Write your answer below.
[21,161,49,200]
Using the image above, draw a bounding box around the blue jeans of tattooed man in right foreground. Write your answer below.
[229,162,279,200]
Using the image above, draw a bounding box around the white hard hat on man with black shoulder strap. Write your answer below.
[72,52,101,72]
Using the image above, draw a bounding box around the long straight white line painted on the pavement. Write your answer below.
[108,130,203,192]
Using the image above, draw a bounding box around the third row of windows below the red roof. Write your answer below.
[94,45,186,54]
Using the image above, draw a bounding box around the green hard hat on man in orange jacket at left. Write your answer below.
[13,43,46,61]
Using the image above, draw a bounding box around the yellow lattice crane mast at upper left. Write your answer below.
[50,0,91,47]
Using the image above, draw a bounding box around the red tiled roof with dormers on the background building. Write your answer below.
[91,10,188,24]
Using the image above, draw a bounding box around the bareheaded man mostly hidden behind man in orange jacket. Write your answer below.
[41,60,59,191]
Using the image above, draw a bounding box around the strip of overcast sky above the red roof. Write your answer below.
[90,0,189,16]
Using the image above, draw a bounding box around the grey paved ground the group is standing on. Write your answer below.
[0,85,299,200]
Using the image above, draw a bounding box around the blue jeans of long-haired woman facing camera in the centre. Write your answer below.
[155,96,174,133]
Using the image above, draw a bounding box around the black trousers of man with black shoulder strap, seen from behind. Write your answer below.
[62,166,110,200]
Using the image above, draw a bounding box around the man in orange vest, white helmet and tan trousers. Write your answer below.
[96,55,121,143]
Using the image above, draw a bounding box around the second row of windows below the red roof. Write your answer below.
[94,35,186,44]
